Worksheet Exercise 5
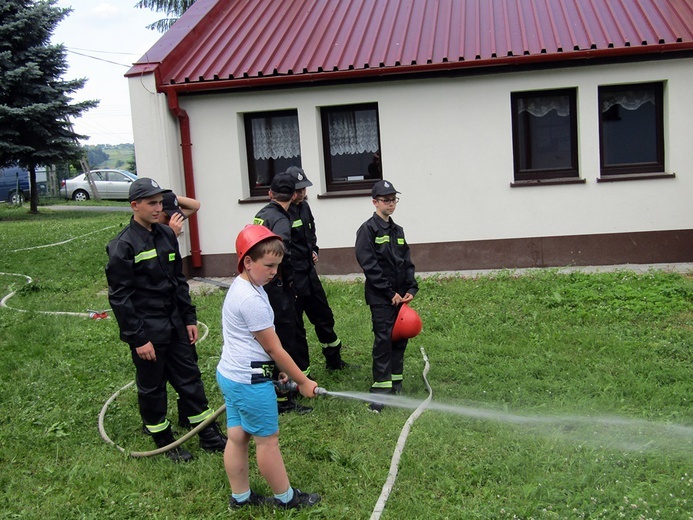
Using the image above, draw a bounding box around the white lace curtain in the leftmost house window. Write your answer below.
[251,116,301,159]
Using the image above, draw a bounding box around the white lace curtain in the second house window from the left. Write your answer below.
[328,110,379,155]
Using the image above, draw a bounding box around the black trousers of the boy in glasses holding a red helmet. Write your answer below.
[370,305,408,394]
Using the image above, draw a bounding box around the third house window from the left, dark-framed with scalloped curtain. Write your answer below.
[511,89,579,181]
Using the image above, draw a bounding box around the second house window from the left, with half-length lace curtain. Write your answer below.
[321,103,383,191]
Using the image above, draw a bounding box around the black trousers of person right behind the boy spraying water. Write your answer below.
[265,280,310,374]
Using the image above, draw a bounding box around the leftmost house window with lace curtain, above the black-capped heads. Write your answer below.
[245,110,301,196]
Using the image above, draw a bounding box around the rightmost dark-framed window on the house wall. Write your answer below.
[599,83,664,176]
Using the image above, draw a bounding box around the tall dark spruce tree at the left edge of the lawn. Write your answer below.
[0,0,98,213]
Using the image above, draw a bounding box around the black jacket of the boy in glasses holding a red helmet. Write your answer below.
[356,213,419,305]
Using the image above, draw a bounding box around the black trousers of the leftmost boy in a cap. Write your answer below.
[131,333,209,427]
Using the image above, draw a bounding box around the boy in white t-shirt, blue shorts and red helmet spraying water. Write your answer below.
[217,225,320,509]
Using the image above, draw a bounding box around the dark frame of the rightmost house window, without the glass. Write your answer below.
[597,81,664,178]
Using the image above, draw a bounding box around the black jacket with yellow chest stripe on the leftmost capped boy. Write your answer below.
[106,218,197,348]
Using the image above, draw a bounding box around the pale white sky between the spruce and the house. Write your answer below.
[51,0,163,145]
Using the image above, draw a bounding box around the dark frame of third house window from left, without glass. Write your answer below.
[510,88,580,182]
